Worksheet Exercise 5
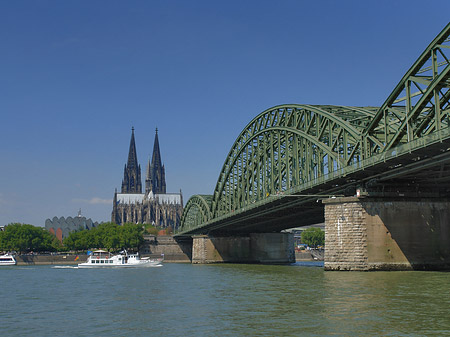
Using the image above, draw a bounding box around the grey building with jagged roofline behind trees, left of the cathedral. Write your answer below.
[45,209,99,242]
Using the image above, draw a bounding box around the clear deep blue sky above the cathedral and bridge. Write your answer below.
[0,0,450,226]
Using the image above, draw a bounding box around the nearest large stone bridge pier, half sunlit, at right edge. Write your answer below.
[323,197,450,270]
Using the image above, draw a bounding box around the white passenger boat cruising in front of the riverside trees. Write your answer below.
[78,250,164,268]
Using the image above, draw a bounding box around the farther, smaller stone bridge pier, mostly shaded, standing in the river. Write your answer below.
[192,233,295,264]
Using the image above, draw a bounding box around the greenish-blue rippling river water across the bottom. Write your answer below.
[0,263,450,337]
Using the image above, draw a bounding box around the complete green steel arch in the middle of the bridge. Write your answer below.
[211,105,373,218]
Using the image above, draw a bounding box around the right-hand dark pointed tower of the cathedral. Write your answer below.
[145,129,166,194]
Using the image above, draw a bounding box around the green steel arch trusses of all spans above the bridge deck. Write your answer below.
[181,24,450,233]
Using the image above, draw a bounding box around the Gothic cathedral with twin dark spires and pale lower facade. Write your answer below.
[111,128,183,229]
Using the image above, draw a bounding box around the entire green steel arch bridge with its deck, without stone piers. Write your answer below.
[177,24,450,236]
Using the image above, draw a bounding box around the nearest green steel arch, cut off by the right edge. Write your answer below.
[364,24,450,156]
